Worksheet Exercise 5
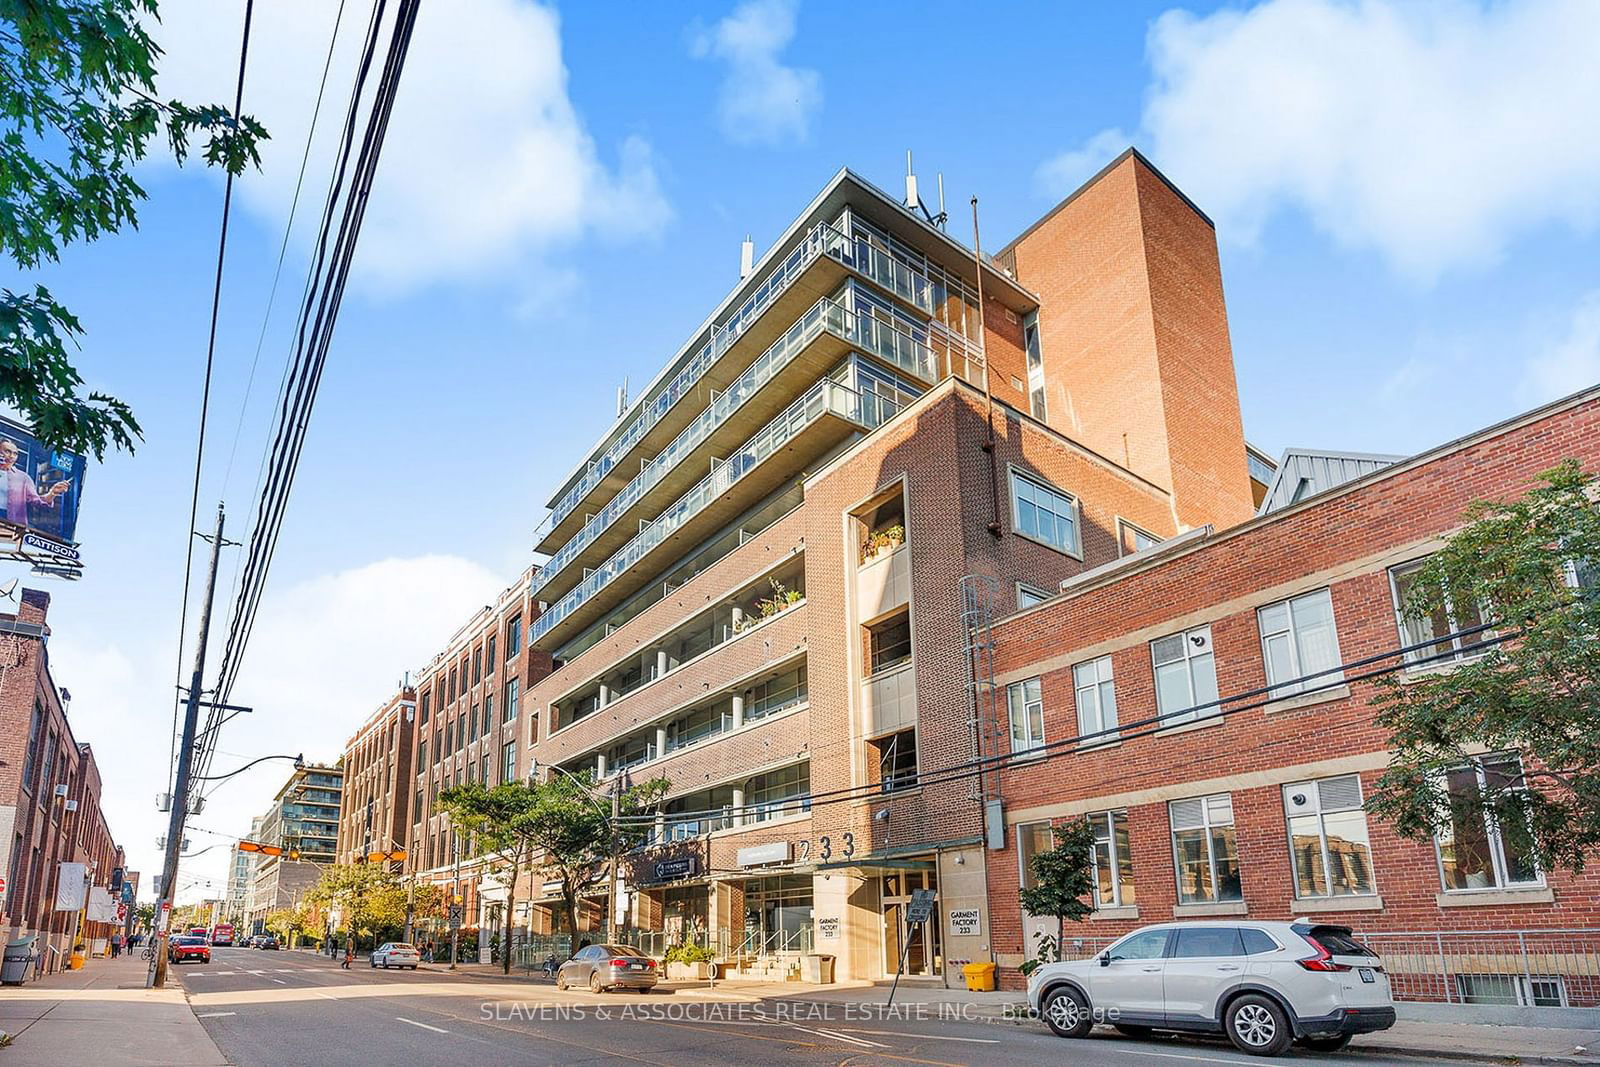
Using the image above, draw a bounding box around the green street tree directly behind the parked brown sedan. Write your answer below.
[518,771,669,939]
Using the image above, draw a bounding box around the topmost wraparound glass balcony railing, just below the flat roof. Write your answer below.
[534,222,979,542]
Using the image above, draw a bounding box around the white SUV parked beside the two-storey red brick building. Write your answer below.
[1027,920,1395,1056]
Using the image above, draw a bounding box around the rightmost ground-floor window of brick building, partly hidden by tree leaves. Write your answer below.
[1438,753,1544,893]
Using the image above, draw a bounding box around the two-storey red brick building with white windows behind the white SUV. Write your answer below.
[987,389,1600,1006]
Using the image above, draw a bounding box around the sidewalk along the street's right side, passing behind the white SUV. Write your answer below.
[422,963,1600,1067]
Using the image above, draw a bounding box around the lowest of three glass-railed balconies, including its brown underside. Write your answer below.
[528,366,899,651]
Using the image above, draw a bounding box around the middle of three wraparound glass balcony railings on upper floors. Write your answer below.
[533,298,939,593]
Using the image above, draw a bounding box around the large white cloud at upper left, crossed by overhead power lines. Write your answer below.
[157,0,670,288]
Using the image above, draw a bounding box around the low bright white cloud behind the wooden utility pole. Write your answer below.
[51,555,506,897]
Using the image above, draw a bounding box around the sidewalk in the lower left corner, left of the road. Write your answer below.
[0,952,227,1067]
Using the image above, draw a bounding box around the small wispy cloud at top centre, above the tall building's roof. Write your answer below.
[690,0,822,144]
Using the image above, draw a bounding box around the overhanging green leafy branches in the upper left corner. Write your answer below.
[0,0,267,459]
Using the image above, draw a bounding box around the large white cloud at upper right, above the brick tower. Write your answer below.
[1040,0,1600,282]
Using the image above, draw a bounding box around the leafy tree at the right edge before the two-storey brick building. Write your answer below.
[1366,461,1600,870]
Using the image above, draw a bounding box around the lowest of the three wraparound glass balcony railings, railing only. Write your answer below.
[531,369,899,640]
